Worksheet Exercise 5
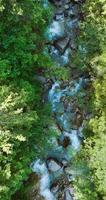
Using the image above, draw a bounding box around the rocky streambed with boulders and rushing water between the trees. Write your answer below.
[32,0,89,200]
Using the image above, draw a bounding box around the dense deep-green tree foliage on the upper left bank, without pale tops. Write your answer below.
[0,0,50,79]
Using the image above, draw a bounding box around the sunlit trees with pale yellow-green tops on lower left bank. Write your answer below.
[0,81,52,200]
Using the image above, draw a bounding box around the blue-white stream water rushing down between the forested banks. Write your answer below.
[32,0,88,200]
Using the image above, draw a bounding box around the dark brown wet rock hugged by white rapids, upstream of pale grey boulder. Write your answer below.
[58,134,70,148]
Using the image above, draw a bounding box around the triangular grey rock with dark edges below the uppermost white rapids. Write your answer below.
[54,37,70,54]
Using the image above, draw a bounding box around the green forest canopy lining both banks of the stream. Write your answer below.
[0,0,106,200]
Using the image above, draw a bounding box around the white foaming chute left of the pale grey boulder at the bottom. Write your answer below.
[32,159,56,200]
